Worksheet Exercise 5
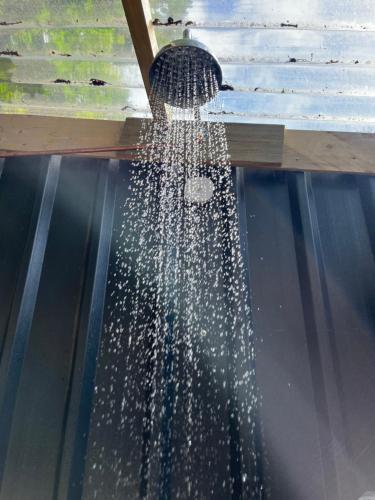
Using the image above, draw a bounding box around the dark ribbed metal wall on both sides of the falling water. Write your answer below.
[0,157,375,500]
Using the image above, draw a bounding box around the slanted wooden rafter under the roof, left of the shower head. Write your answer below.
[122,0,158,101]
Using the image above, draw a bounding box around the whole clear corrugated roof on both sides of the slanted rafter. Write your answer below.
[0,0,375,132]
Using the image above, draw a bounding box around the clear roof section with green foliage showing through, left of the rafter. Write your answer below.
[0,0,150,120]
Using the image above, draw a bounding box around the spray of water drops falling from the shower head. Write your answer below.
[85,47,263,500]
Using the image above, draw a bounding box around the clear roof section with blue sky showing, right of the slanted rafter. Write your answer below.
[153,0,375,132]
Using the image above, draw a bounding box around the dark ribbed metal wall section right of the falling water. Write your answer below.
[245,171,375,500]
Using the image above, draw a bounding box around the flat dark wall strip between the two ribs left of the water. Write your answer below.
[2,160,104,500]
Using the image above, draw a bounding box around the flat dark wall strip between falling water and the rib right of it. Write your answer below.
[244,170,324,500]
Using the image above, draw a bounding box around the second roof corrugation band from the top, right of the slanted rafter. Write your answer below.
[158,25,375,65]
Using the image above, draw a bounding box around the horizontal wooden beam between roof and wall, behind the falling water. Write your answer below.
[0,114,375,174]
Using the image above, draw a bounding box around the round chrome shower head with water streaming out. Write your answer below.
[149,29,223,108]
